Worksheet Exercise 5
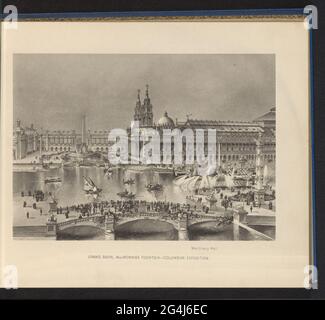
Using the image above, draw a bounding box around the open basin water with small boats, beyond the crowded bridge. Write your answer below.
[13,167,185,206]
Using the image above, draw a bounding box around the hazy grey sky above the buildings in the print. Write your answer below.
[13,54,275,131]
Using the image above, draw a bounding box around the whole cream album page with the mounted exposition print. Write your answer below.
[0,11,313,287]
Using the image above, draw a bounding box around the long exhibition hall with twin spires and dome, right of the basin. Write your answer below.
[133,86,276,166]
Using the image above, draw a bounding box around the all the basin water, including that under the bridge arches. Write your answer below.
[13,167,275,240]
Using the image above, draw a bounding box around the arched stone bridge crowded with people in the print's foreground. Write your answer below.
[46,196,275,240]
